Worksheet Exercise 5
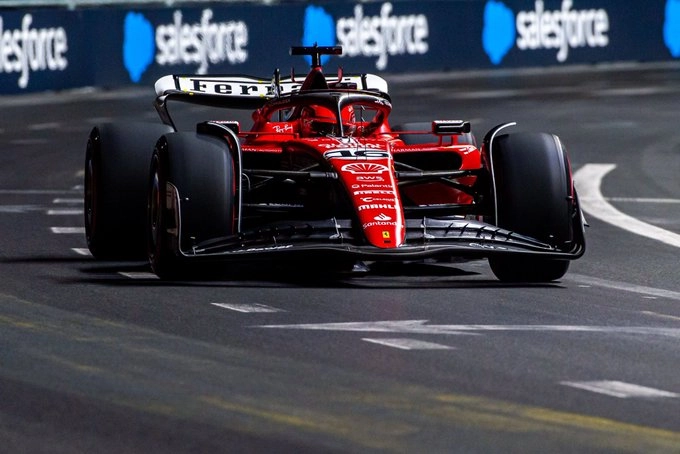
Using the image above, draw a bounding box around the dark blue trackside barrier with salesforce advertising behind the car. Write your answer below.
[0,0,680,94]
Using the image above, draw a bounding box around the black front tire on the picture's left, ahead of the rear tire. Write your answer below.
[147,132,235,279]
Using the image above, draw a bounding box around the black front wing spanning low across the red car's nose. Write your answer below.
[174,218,585,261]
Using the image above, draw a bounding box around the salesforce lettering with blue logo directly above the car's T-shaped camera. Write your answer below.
[302,2,430,70]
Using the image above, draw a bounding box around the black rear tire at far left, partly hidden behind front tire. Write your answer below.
[84,123,172,260]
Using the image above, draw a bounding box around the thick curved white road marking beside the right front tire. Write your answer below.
[574,164,680,247]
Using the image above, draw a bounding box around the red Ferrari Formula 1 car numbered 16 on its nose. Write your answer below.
[85,46,585,282]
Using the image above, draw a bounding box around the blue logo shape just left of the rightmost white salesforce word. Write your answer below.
[482,0,517,65]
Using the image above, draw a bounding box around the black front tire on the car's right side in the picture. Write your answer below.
[489,133,577,282]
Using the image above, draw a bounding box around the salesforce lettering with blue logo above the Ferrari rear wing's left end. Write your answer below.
[123,9,248,82]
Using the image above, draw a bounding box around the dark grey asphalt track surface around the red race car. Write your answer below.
[0,65,680,453]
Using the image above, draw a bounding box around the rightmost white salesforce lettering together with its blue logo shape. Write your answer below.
[482,0,612,65]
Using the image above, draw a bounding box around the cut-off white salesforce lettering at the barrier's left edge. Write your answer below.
[0,14,68,88]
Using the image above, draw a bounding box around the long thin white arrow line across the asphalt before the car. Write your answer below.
[257,320,680,339]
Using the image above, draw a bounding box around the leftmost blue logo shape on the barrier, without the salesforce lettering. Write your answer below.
[123,12,156,83]
